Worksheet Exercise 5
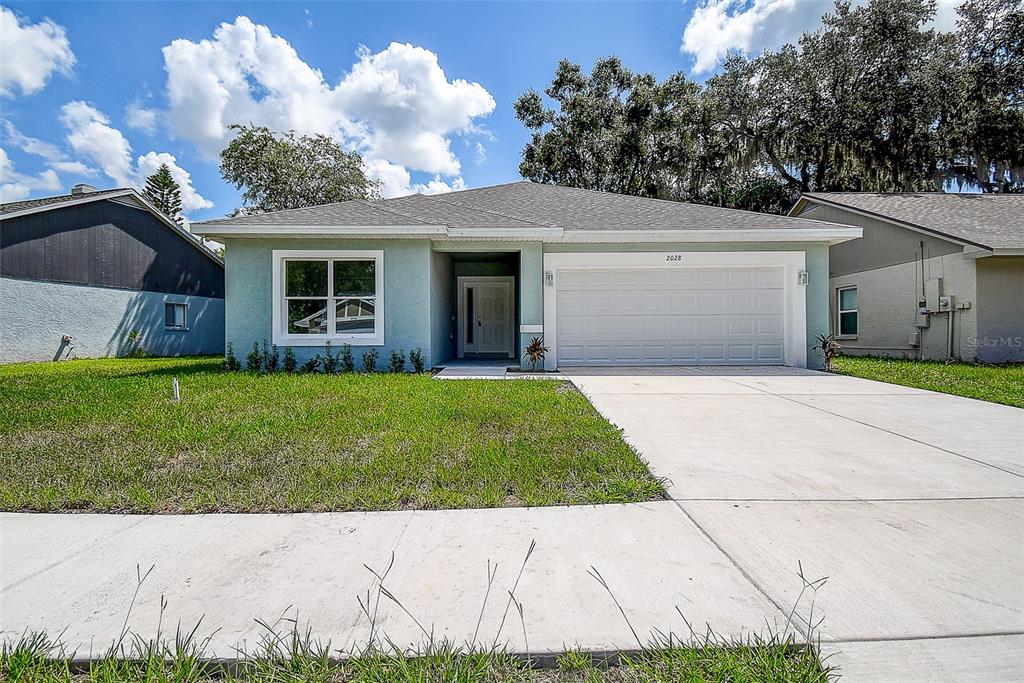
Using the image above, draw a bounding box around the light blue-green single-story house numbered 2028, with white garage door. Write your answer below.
[193,181,860,370]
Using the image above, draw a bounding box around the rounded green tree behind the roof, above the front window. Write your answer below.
[220,125,379,214]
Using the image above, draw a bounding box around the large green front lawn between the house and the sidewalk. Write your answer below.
[0,358,664,513]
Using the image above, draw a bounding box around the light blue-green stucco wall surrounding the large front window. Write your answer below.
[224,239,432,369]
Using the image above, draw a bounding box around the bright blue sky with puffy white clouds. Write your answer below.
[0,0,962,220]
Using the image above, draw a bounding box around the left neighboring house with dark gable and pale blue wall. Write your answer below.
[0,185,224,362]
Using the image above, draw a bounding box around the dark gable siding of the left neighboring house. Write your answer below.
[0,201,224,298]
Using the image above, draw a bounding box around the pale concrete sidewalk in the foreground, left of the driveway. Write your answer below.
[0,501,786,656]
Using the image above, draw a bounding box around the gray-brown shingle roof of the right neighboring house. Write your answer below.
[804,193,1024,249]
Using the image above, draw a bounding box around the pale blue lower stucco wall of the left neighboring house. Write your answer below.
[0,278,224,362]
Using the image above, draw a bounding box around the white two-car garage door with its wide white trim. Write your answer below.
[545,252,806,369]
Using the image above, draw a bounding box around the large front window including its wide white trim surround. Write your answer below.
[273,250,384,346]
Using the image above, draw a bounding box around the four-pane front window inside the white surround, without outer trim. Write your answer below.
[283,252,380,341]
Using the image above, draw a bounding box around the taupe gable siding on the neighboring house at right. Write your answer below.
[799,203,964,278]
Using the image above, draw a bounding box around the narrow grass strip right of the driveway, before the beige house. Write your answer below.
[836,356,1024,408]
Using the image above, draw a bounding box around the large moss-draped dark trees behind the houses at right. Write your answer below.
[515,0,1024,212]
